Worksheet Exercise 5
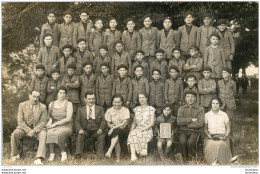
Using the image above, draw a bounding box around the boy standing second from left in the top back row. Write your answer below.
[59,11,74,49]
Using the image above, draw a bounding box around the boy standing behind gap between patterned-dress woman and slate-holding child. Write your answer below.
[149,69,164,116]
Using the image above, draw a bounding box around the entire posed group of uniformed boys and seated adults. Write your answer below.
[11,10,240,164]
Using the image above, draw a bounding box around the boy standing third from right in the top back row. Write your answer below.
[176,12,198,60]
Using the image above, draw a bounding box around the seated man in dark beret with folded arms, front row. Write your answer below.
[177,91,205,161]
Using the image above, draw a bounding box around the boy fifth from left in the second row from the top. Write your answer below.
[111,40,132,78]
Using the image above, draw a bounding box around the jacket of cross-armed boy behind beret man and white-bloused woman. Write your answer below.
[198,78,217,107]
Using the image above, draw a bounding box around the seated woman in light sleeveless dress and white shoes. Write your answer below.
[46,86,73,161]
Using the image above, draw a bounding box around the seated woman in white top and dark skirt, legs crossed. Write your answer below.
[105,94,130,162]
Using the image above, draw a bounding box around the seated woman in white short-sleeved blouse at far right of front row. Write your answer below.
[204,98,232,165]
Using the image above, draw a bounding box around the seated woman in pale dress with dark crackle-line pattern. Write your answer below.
[127,93,155,161]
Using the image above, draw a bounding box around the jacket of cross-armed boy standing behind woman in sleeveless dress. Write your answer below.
[61,73,80,104]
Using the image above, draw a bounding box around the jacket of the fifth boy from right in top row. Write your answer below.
[139,27,159,56]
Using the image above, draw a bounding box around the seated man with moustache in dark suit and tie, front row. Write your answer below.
[75,92,106,159]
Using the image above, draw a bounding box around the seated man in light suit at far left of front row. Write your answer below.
[11,91,47,165]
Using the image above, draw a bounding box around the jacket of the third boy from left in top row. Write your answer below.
[73,21,93,50]
